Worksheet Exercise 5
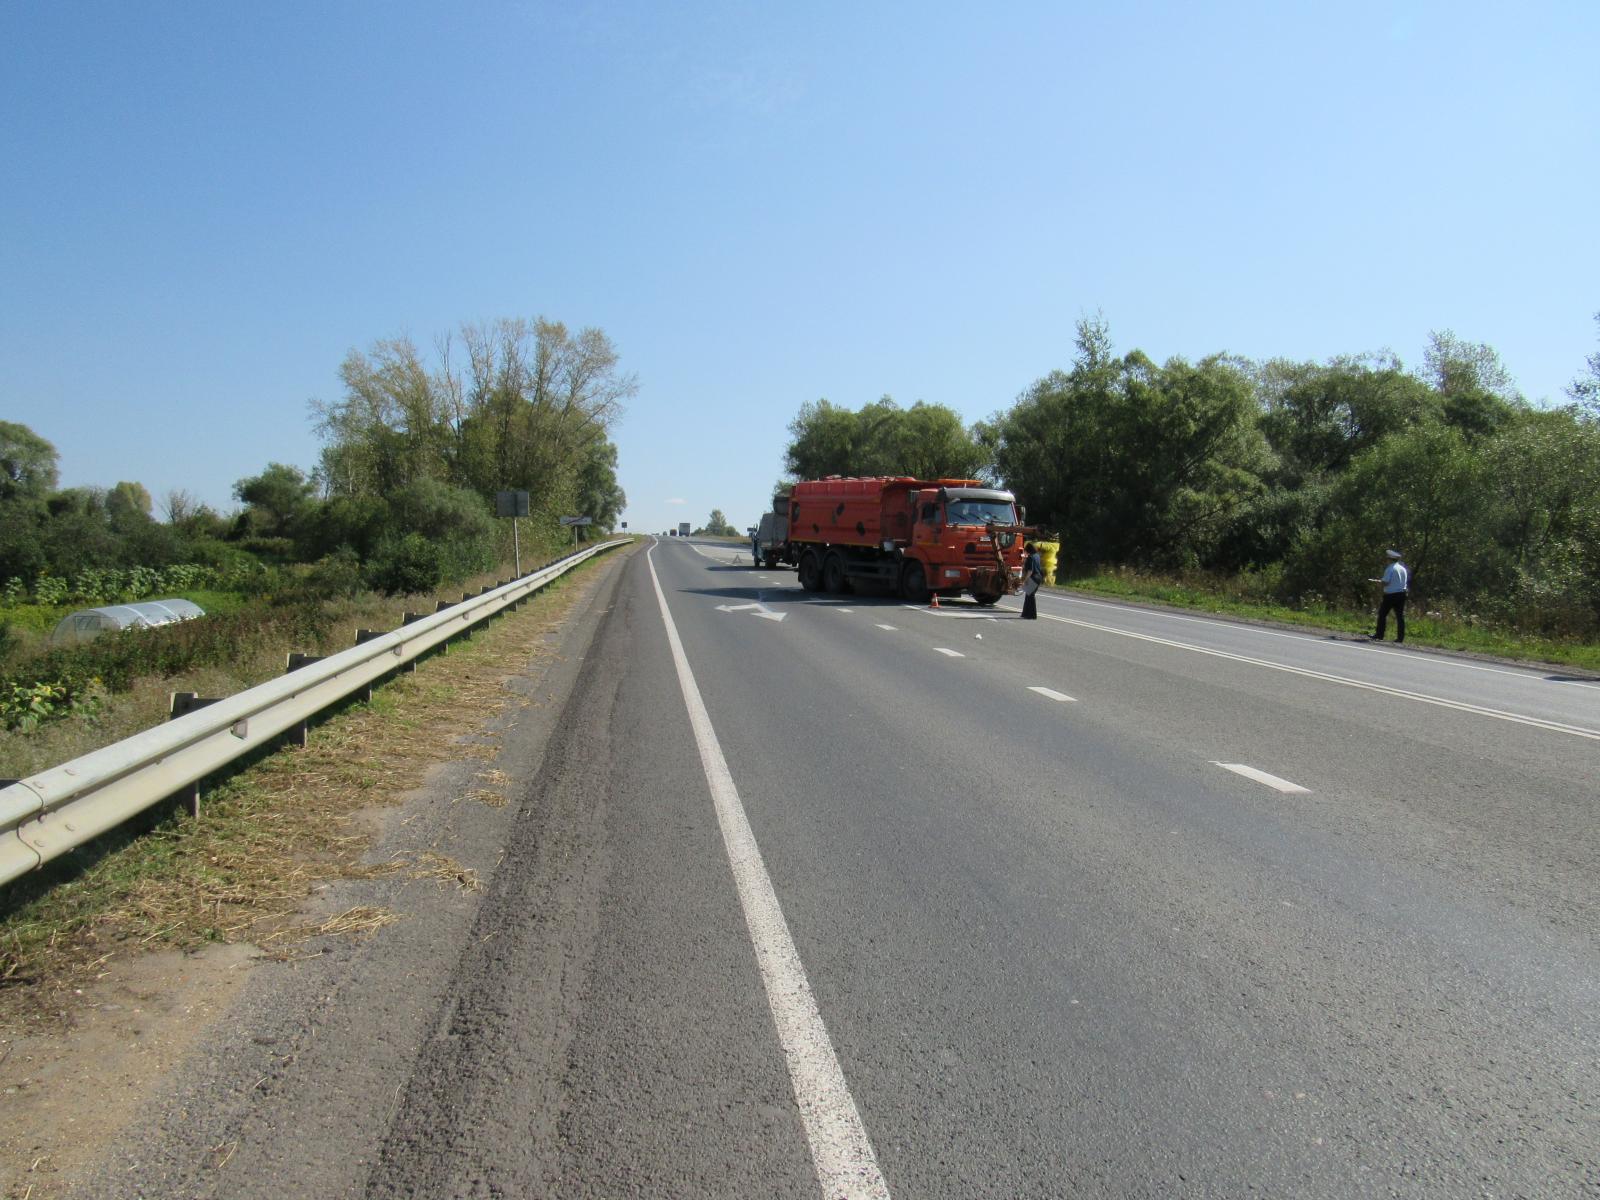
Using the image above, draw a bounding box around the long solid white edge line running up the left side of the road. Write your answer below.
[645,547,890,1200]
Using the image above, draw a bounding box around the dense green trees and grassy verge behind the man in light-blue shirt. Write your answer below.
[784,317,1600,667]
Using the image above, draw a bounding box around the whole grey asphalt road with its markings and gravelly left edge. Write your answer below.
[81,539,1600,1198]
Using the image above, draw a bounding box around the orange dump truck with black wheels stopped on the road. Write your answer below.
[784,475,1027,605]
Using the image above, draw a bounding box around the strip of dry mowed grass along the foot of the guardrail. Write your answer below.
[0,566,611,1029]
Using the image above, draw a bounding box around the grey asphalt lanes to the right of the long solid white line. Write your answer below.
[654,546,1600,1195]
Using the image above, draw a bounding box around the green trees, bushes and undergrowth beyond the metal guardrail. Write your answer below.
[0,318,637,752]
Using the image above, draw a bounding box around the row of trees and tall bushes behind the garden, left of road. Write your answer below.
[0,317,638,594]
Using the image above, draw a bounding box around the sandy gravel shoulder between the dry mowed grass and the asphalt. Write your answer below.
[0,554,627,1200]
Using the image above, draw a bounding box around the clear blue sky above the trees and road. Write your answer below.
[0,0,1600,530]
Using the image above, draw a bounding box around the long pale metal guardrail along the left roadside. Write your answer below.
[0,539,627,883]
